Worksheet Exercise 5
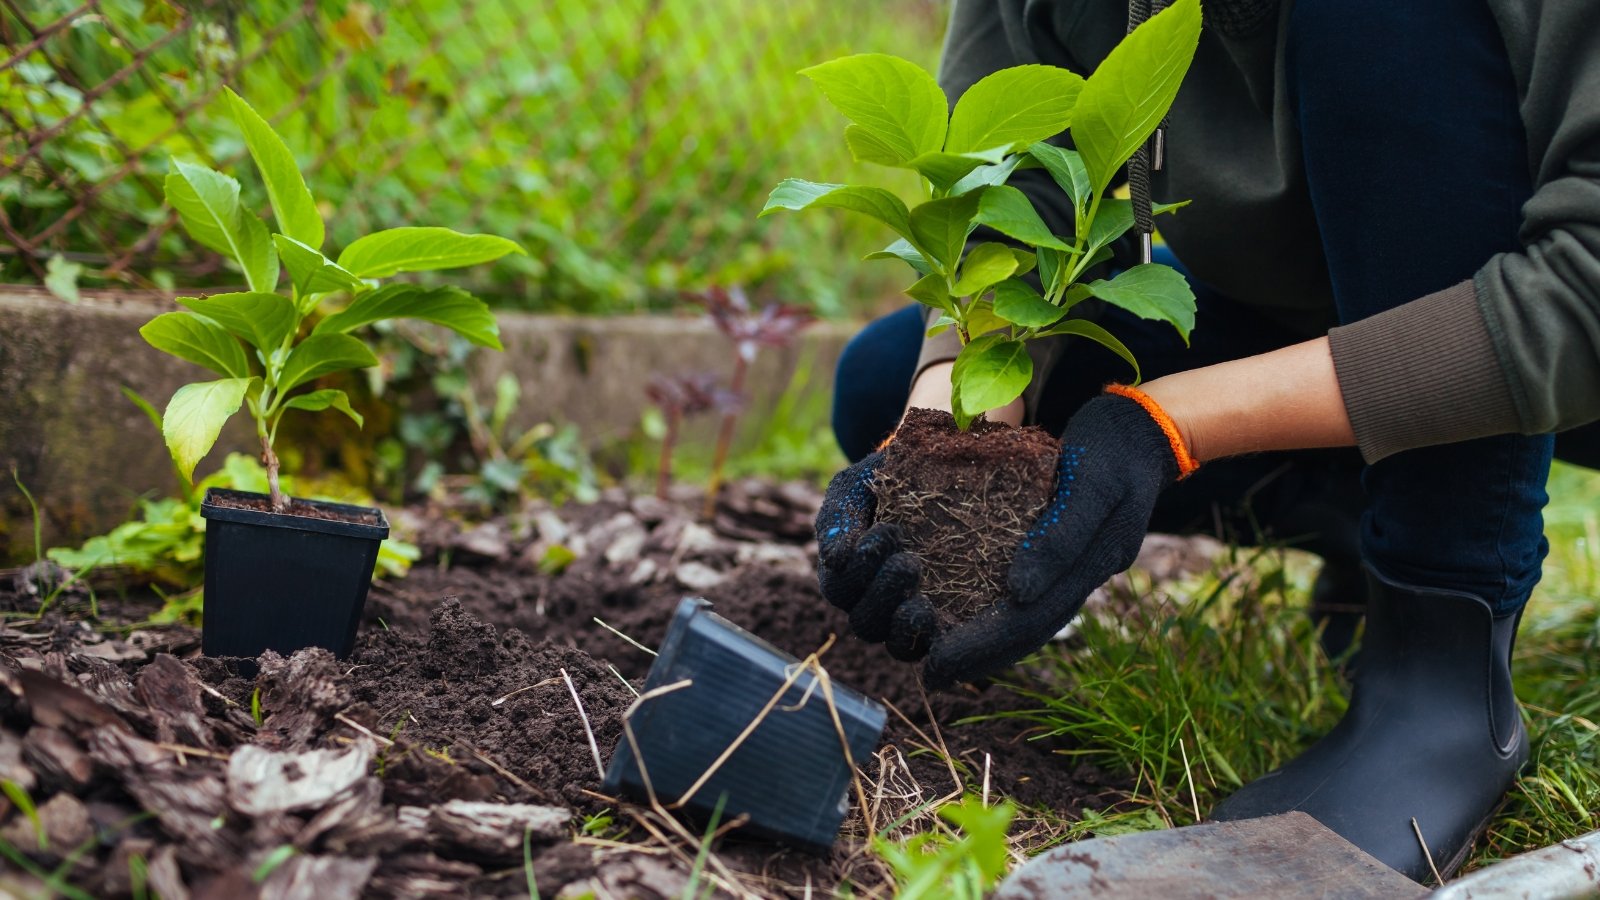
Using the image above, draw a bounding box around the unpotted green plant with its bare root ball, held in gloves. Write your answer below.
[762,0,1200,625]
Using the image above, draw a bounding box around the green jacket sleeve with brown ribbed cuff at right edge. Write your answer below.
[1330,0,1600,461]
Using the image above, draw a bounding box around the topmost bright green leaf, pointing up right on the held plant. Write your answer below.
[1072,0,1200,194]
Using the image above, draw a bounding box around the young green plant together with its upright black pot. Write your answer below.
[139,91,522,657]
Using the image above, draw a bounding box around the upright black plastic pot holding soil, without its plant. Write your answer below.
[200,488,389,658]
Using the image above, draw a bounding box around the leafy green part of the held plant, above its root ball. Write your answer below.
[762,0,1200,429]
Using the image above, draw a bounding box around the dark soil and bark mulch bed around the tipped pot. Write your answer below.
[0,482,1152,900]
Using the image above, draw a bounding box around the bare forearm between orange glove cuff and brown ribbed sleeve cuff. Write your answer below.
[1142,338,1355,463]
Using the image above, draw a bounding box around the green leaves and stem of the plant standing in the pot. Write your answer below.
[139,91,523,512]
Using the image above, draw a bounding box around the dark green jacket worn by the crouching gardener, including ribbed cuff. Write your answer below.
[918,0,1600,461]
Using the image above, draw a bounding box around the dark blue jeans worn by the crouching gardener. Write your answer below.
[834,0,1600,615]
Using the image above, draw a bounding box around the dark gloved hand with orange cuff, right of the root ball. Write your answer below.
[923,386,1197,687]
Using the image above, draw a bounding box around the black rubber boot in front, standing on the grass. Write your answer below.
[1211,569,1528,881]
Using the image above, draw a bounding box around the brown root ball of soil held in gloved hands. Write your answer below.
[872,410,1061,628]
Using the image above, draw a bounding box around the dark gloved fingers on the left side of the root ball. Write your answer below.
[816,450,934,660]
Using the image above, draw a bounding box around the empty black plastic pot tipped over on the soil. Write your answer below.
[605,599,886,850]
